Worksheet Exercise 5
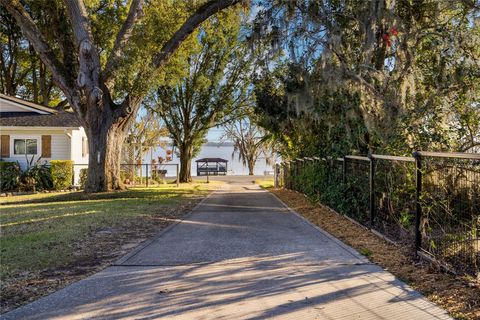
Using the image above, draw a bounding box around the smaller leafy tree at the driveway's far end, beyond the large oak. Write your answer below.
[152,10,251,182]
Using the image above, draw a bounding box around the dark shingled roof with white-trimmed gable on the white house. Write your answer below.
[0,94,81,128]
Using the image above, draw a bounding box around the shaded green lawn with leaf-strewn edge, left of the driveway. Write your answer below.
[0,183,214,311]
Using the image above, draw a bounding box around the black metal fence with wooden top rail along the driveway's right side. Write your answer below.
[275,152,480,276]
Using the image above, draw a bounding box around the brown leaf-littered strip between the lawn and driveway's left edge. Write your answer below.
[0,197,201,313]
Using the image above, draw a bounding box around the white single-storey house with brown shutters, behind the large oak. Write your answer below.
[0,94,88,184]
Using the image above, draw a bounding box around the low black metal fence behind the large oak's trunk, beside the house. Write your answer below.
[73,163,179,187]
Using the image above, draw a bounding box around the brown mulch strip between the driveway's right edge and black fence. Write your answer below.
[270,189,480,319]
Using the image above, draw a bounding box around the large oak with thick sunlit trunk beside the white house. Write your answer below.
[0,0,240,192]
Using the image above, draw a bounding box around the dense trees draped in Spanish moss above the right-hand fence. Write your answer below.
[253,0,480,159]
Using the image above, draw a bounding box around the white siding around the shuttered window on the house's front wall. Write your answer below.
[1,128,70,169]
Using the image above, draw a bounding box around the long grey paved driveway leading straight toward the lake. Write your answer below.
[1,185,449,320]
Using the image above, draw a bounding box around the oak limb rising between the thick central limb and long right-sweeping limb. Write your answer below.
[103,0,145,88]
